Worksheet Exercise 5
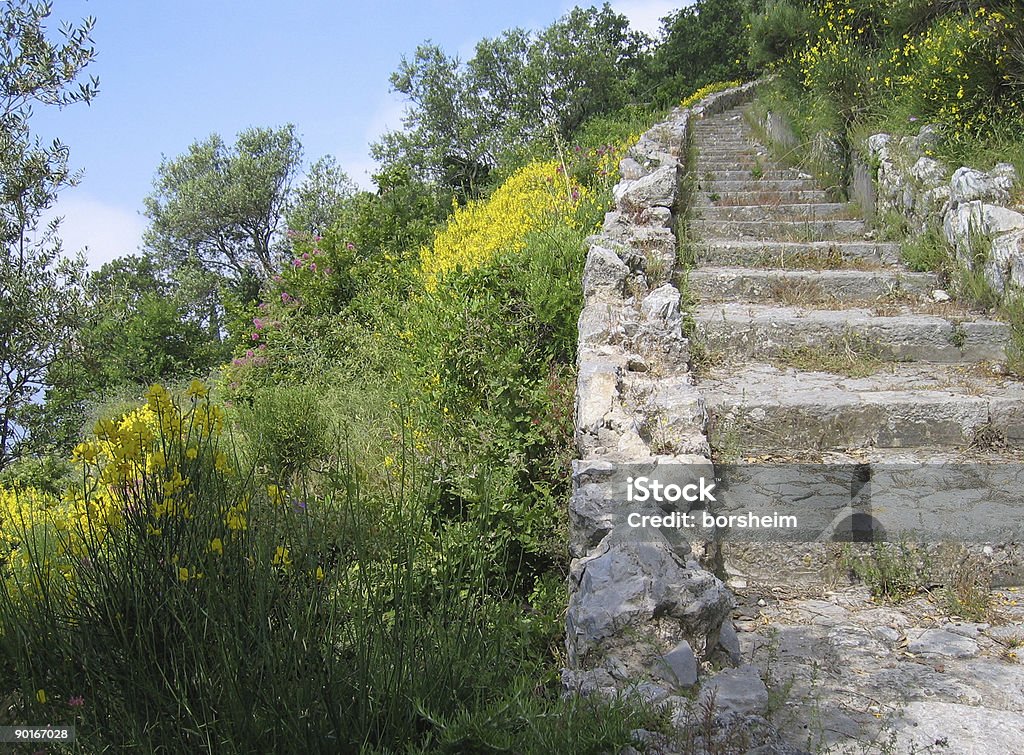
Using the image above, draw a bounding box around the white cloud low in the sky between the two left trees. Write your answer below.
[43,197,145,269]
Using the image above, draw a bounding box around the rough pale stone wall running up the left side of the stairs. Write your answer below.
[562,82,761,702]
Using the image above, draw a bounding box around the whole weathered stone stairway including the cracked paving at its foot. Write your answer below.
[686,110,1024,753]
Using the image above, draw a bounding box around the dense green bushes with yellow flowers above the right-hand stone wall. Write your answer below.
[750,0,1024,167]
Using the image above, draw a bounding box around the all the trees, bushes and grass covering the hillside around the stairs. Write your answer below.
[0,0,1024,753]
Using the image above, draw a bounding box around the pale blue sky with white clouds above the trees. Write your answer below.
[33,0,688,267]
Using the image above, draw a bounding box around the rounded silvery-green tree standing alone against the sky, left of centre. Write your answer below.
[143,124,302,284]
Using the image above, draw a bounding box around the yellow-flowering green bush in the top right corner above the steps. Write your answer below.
[759,0,1024,145]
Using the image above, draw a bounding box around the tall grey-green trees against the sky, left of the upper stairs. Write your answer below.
[374,3,649,197]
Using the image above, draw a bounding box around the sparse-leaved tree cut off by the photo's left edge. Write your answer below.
[0,0,99,469]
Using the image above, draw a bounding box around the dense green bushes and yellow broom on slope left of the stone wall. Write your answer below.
[0,98,656,741]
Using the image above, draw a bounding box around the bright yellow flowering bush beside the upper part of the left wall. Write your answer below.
[420,161,588,291]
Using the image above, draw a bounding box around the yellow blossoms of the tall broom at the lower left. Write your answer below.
[0,381,248,596]
